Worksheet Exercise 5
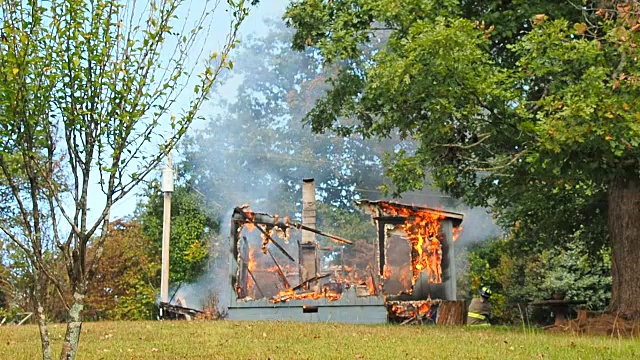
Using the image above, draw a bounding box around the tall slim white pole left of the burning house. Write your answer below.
[160,154,173,303]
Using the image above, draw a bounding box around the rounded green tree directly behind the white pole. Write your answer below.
[136,181,220,285]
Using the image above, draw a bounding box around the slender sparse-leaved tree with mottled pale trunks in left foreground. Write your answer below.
[0,0,248,359]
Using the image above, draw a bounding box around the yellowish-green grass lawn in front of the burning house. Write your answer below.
[0,321,640,360]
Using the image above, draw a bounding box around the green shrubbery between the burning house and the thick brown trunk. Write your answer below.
[459,234,611,323]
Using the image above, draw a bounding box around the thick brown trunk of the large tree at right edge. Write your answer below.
[608,179,640,319]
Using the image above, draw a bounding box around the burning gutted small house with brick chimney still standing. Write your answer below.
[228,179,463,323]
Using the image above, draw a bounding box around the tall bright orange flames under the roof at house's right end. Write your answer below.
[379,202,444,288]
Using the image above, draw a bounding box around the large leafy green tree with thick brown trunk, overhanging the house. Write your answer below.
[285,0,640,318]
